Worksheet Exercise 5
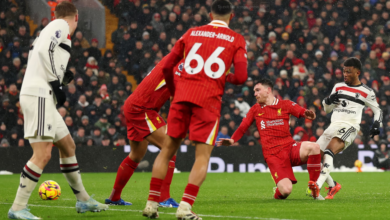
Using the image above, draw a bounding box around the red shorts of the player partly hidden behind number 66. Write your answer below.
[123,105,165,141]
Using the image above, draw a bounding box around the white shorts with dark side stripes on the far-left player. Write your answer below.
[20,95,69,143]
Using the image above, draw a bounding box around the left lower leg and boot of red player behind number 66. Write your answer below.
[105,140,148,205]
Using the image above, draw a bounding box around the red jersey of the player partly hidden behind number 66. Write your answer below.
[126,56,183,112]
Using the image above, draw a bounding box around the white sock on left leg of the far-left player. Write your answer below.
[12,161,42,211]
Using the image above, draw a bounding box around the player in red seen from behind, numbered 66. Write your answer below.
[143,0,248,219]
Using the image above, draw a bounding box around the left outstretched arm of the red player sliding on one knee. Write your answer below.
[216,107,255,146]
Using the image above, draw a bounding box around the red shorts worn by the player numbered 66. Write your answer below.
[167,102,220,146]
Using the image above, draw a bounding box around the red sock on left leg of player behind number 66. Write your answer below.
[110,156,138,201]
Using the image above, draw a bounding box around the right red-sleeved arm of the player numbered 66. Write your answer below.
[226,37,248,85]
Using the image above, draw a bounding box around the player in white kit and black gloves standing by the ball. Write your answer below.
[8,2,108,219]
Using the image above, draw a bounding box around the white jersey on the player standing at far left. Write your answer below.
[20,19,71,97]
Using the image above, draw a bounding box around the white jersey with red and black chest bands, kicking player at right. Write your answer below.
[322,82,383,128]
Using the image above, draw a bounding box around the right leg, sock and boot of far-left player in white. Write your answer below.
[55,134,108,213]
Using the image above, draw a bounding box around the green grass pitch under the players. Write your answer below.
[0,172,390,220]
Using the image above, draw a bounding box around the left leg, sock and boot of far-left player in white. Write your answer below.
[8,140,53,219]
